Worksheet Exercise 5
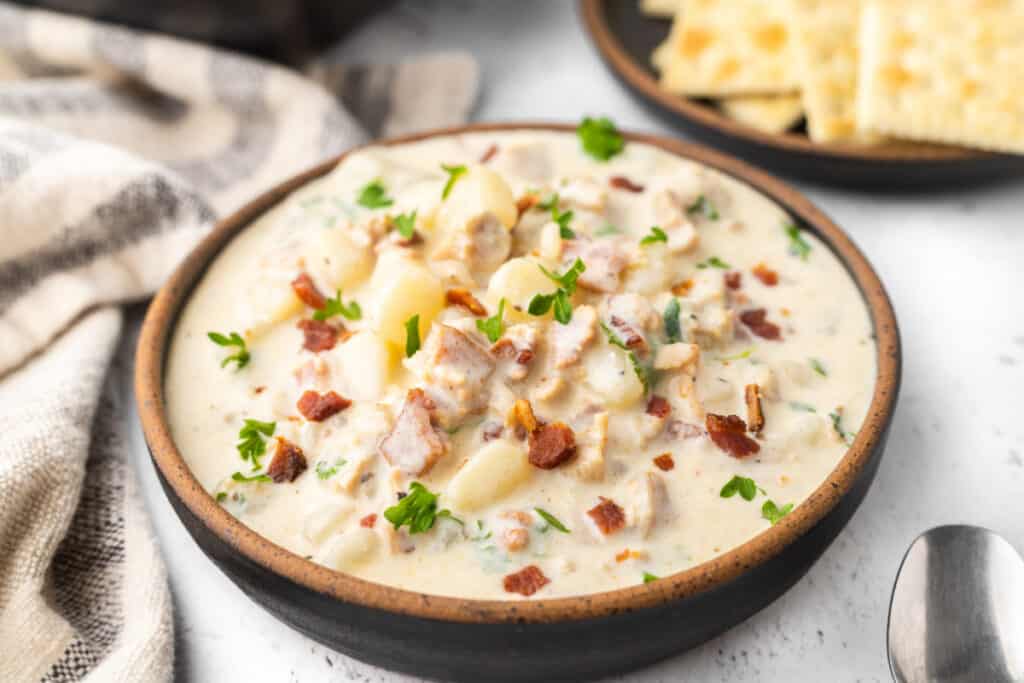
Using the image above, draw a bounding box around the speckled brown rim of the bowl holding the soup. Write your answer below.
[134,123,901,624]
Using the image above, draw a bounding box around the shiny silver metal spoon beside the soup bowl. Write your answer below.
[888,525,1024,683]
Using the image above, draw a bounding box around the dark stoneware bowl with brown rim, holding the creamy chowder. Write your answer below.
[135,124,900,681]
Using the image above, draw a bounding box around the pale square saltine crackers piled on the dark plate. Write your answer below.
[641,0,1024,154]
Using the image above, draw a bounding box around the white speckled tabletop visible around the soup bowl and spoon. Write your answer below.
[119,0,1024,683]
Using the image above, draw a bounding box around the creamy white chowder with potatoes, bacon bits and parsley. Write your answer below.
[166,126,876,599]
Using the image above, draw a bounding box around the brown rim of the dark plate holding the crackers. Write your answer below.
[580,0,1004,165]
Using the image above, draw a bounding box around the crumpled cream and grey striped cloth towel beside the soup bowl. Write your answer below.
[0,4,477,682]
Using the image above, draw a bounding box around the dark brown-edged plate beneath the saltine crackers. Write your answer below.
[580,0,1024,189]
